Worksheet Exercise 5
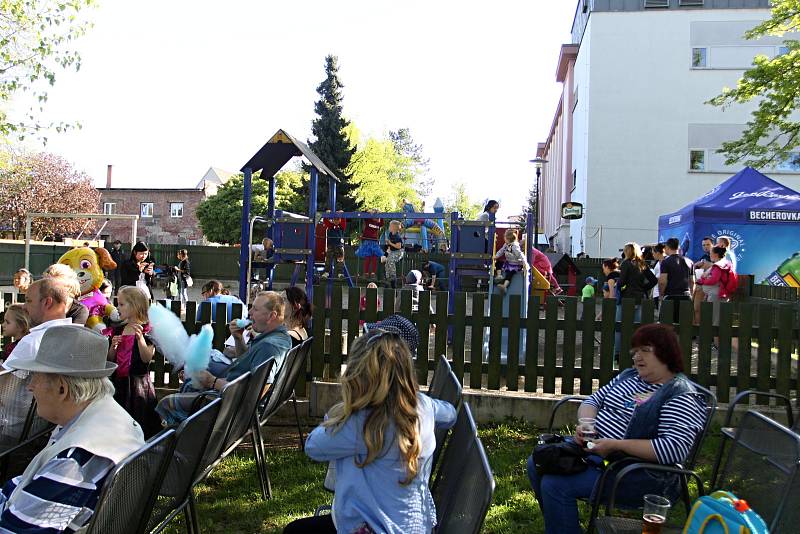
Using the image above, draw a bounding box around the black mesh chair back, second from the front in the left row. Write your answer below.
[147,399,222,533]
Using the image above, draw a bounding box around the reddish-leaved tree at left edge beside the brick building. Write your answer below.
[0,153,100,239]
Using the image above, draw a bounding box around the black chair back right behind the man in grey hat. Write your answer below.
[85,430,175,534]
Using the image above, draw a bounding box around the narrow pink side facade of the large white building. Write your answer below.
[536,45,578,253]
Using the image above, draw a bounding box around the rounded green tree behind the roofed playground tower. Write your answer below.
[197,170,308,245]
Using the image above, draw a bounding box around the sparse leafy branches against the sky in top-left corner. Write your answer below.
[0,0,95,142]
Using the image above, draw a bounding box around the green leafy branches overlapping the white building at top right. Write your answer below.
[708,0,800,167]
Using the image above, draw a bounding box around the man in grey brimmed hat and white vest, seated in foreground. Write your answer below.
[0,325,144,533]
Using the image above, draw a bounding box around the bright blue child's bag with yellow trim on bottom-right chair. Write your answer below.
[683,491,769,534]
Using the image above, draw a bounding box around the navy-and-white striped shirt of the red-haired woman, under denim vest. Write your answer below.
[585,375,706,464]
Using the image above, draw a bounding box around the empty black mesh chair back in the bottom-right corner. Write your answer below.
[716,410,800,534]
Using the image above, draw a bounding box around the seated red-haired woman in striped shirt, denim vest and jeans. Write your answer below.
[528,324,706,534]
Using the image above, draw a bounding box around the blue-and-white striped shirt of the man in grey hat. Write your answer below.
[0,447,114,534]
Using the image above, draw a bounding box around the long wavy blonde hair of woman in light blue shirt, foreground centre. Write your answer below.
[323,329,422,485]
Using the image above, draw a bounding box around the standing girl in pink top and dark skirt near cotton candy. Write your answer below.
[103,286,161,439]
